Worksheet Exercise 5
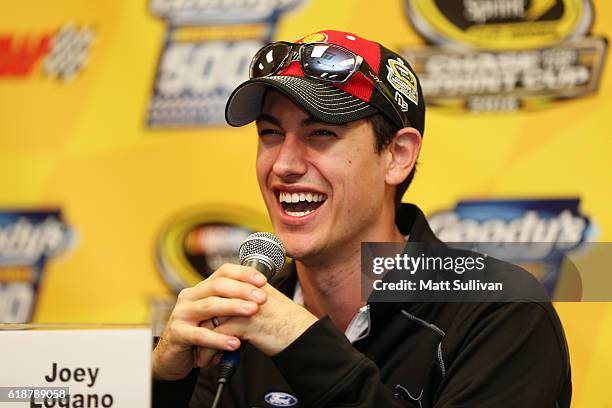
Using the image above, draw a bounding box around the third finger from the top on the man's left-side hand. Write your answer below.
[175,296,259,321]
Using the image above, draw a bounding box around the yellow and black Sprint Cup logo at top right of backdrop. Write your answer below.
[402,0,607,112]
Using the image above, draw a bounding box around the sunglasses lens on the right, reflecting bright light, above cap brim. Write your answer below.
[302,44,357,82]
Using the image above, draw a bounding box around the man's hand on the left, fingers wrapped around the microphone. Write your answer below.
[153,264,269,380]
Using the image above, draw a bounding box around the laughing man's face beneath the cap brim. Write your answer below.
[257,91,392,262]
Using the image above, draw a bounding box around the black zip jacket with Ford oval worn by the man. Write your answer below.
[153,205,571,408]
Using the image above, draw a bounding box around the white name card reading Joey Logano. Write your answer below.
[0,325,152,408]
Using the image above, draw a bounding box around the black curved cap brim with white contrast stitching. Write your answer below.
[225,76,378,126]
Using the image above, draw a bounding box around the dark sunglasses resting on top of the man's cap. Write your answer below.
[249,41,411,127]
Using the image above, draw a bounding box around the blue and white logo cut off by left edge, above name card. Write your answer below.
[0,210,74,323]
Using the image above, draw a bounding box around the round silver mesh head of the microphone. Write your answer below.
[238,232,285,274]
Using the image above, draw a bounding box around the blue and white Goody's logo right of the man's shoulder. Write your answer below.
[429,198,595,296]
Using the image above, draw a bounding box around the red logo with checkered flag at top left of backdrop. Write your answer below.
[0,24,95,82]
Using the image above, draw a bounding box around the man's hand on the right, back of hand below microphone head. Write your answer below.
[214,284,318,356]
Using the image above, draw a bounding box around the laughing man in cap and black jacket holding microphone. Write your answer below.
[153,31,571,407]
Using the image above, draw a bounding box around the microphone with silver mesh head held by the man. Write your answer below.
[212,232,285,408]
